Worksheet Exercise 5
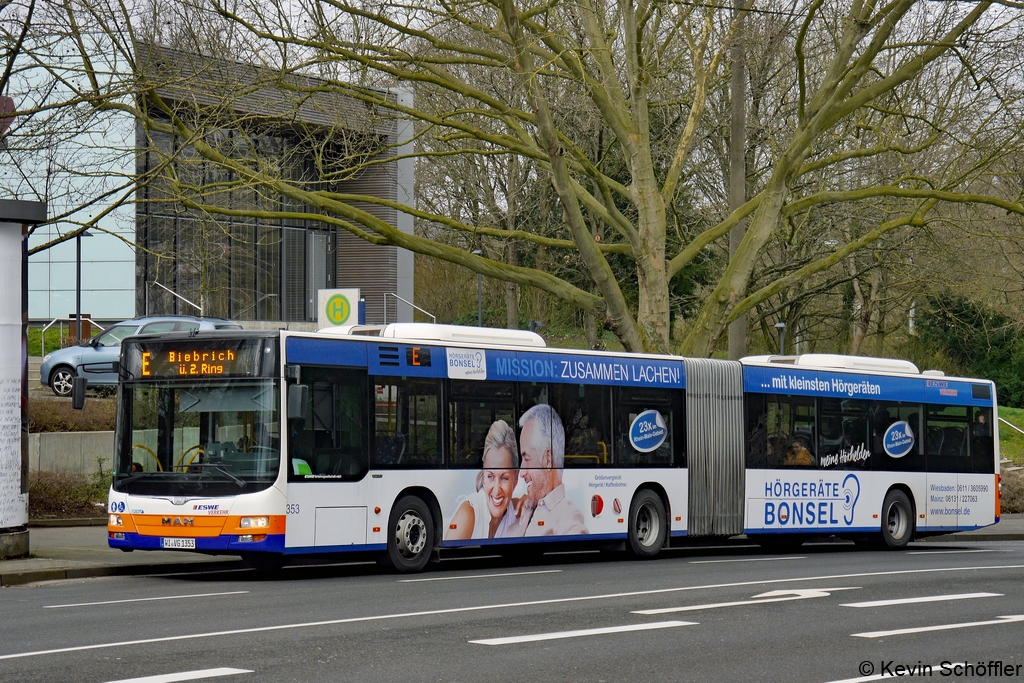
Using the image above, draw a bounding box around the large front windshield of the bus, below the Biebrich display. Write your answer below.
[114,379,281,496]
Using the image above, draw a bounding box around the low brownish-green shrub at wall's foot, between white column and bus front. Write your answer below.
[29,470,110,519]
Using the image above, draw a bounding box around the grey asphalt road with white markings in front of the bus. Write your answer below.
[0,542,1024,683]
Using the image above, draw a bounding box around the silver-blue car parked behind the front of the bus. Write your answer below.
[39,315,242,396]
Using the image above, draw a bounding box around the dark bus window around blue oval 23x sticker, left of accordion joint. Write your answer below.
[612,387,686,467]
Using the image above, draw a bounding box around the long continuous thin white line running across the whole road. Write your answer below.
[0,564,1024,660]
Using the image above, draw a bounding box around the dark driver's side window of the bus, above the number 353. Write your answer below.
[288,366,370,481]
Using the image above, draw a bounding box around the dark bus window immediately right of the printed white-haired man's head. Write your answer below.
[551,384,612,467]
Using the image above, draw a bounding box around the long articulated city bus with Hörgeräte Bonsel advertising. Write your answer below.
[108,324,999,571]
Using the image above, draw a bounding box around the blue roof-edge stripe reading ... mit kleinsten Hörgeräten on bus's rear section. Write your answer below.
[743,366,992,407]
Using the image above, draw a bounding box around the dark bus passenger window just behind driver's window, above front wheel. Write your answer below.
[373,377,443,468]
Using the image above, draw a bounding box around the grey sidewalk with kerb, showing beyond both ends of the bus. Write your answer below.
[0,514,1024,586]
